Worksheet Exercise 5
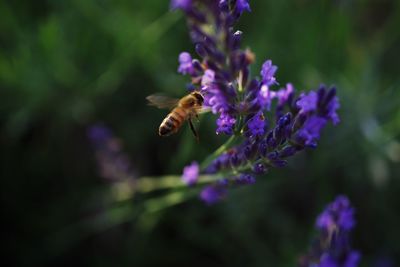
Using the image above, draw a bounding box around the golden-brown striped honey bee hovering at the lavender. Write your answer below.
[146,91,206,140]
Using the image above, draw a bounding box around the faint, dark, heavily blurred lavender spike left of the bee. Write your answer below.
[87,124,134,182]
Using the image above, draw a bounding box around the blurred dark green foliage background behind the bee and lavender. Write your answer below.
[0,0,400,266]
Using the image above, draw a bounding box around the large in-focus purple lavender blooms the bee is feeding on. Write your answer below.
[176,0,339,203]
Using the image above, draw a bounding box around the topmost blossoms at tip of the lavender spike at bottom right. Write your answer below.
[317,196,355,231]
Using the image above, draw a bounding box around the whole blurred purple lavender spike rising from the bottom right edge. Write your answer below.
[298,196,361,267]
